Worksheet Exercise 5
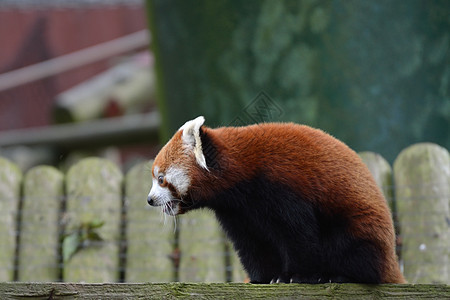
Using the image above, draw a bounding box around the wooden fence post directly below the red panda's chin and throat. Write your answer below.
[178,210,226,282]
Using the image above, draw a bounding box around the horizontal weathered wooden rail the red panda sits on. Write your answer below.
[0,282,450,300]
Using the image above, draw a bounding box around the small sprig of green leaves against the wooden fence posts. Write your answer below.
[62,219,105,263]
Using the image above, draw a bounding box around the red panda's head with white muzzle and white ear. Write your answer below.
[147,116,208,215]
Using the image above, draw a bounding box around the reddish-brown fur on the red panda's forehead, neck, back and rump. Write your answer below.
[155,124,405,283]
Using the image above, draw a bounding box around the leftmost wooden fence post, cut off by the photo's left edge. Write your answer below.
[0,157,22,281]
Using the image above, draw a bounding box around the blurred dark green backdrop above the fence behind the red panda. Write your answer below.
[146,0,450,161]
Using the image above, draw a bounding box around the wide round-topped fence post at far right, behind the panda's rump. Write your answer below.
[394,144,450,284]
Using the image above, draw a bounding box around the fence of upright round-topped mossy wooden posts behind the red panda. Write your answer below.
[0,144,450,288]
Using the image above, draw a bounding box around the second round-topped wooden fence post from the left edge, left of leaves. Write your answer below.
[18,166,64,282]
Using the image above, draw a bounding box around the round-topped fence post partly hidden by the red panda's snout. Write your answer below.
[124,163,175,282]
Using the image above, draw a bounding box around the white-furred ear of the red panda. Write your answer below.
[178,116,208,170]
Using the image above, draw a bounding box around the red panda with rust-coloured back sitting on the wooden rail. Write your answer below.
[147,117,405,283]
